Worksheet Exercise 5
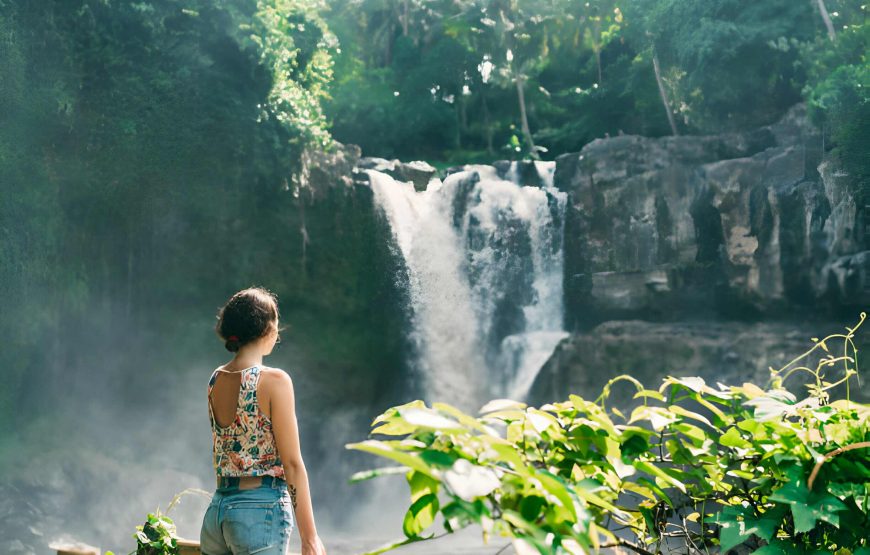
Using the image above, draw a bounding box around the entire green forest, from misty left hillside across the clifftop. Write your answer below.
[0,0,870,552]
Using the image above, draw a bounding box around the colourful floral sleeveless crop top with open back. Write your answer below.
[208,366,284,478]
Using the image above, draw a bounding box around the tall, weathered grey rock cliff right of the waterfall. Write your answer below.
[554,105,870,328]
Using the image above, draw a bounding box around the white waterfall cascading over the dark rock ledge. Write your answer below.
[365,162,567,409]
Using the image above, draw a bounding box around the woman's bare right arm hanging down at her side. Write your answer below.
[269,369,326,555]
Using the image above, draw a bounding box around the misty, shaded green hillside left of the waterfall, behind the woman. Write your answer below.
[0,0,410,460]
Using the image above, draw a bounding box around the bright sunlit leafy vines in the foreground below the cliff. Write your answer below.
[348,313,870,555]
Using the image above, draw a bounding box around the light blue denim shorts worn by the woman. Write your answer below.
[199,477,293,555]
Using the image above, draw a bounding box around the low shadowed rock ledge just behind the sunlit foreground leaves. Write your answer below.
[529,320,870,409]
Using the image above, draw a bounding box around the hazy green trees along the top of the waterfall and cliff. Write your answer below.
[325,0,867,163]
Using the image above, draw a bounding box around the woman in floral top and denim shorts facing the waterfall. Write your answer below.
[200,287,326,555]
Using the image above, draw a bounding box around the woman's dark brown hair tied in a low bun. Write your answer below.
[215,287,278,353]
